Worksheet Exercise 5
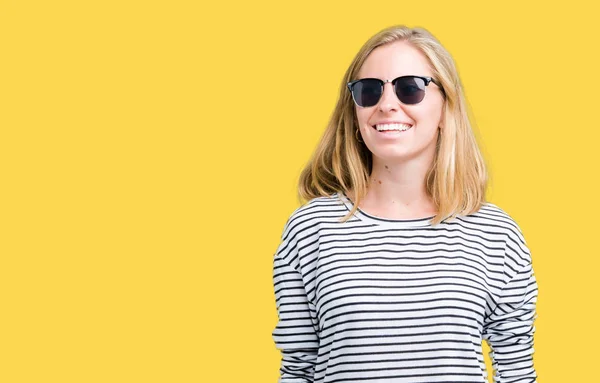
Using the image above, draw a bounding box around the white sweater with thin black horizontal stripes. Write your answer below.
[272,193,537,383]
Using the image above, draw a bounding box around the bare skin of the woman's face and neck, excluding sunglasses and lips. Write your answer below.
[346,41,444,219]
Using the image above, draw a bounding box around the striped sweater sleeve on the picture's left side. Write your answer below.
[272,252,319,383]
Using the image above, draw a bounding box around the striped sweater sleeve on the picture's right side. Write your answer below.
[483,262,538,383]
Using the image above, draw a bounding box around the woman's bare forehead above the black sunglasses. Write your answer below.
[358,41,432,79]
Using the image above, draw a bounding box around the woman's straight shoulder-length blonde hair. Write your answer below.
[298,25,488,225]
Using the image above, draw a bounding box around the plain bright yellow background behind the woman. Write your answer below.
[0,0,600,383]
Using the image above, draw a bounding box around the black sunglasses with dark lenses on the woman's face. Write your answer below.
[347,76,442,108]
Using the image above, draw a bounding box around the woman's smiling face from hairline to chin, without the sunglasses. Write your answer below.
[355,41,444,165]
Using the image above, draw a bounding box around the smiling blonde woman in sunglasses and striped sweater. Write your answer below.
[272,26,537,383]
